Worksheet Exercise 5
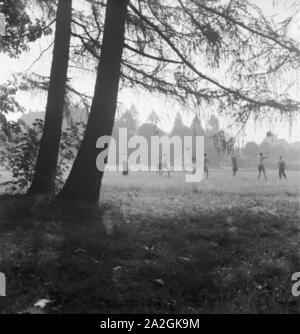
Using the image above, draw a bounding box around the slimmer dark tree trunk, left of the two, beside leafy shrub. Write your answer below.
[29,0,72,195]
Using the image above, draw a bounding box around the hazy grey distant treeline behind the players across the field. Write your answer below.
[21,104,300,169]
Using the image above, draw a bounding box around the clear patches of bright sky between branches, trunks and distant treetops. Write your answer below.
[0,0,300,143]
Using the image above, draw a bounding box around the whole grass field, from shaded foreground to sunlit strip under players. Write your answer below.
[0,170,300,314]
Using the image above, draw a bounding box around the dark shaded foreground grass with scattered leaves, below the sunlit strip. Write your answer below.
[0,196,300,313]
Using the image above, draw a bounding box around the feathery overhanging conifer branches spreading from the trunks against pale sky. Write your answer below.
[68,0,300,124]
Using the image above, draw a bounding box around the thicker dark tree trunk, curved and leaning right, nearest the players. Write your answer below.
[58,0,128,203]
